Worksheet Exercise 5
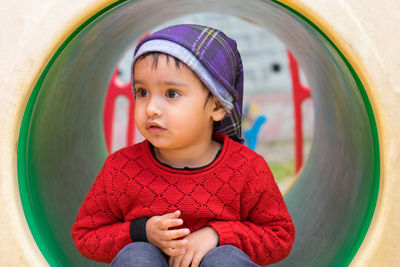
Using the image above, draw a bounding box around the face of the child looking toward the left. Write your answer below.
[133,55,225,150]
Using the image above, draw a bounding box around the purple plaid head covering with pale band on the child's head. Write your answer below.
[131,24,244,143]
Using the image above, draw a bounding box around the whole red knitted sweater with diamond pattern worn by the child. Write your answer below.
[72,135,295,265]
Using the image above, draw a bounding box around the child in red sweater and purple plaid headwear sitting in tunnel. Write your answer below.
[72,25,295,267]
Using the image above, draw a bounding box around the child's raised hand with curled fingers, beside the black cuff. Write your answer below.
[146,210,190,256]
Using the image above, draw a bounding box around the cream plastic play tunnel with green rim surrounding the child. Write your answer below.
[0,0,400,266]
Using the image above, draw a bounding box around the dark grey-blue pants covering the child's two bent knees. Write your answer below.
[111,242,258,267]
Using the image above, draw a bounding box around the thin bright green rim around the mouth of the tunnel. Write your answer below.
[17,0,380,266]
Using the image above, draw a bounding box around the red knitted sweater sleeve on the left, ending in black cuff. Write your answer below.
[72,157,132,263]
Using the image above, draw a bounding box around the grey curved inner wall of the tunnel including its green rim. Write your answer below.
[18,0,379,266]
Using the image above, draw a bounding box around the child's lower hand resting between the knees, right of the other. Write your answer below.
[169,226,218,267]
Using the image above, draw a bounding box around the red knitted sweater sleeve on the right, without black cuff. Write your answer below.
[209,159,295,265]
